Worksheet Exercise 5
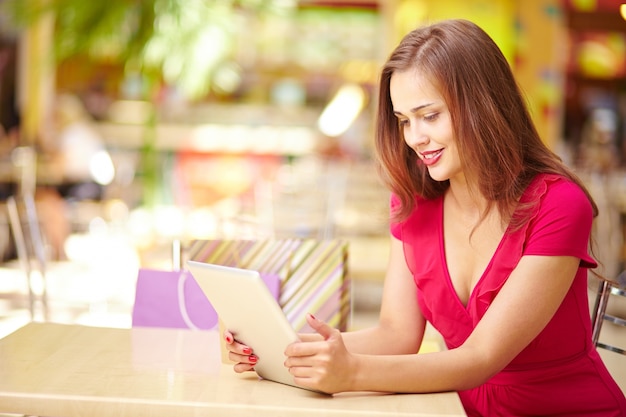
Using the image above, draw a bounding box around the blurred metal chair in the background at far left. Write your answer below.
[7,194,48,320]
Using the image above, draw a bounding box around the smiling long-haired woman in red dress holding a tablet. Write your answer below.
[225,20,626,416]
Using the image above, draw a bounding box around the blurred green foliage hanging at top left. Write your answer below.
[2,0,293,99]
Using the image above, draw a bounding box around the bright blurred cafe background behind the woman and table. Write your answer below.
[0,0,626,398]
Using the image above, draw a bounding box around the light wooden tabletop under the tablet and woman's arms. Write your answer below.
[0,323,465,417]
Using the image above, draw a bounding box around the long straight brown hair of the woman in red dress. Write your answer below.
[376,20,598,229]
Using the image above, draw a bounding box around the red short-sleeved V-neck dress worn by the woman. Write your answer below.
[391,175,626,417]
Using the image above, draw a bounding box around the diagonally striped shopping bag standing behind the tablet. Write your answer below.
[188,239,352,332]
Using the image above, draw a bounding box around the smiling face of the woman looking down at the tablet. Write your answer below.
[389,70,463,181]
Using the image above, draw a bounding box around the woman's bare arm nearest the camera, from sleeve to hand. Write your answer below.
[286,252,580,393]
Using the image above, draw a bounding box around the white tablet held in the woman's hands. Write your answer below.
[187,261,312,388]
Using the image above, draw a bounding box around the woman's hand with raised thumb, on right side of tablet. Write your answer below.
[285,314,357,394]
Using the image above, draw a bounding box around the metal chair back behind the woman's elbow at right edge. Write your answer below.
[592,270,626,355]
